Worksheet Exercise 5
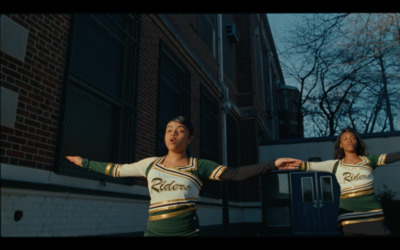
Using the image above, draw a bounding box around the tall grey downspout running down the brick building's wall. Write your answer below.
[217,14,231,233]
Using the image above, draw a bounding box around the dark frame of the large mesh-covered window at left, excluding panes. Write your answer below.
[55,14,141,185]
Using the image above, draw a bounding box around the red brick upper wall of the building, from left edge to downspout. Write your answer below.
[0,14,220,170]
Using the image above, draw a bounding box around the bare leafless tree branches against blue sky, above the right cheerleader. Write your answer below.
[281,14,400,136]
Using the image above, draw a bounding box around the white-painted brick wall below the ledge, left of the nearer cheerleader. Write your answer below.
[1,188,148,237]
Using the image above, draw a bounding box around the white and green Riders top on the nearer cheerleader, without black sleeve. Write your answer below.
[82,156,226,221]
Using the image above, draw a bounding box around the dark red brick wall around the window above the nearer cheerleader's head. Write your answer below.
[136,15,219,159]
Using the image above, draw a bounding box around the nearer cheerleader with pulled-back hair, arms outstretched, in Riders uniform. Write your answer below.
[66,116,301,236]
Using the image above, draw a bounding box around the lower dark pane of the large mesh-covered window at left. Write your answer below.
[63,86,118,161]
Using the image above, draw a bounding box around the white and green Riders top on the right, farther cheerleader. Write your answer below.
[299,154,386,226]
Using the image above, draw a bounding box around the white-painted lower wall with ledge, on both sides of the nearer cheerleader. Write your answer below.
[0,164,261,237]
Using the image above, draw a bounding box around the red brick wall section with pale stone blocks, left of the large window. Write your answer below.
[0,14,70,169]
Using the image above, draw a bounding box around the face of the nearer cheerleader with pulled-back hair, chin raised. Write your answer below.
[164,121,192,153]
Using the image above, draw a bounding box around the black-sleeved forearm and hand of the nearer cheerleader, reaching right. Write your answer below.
[220,158,302,181]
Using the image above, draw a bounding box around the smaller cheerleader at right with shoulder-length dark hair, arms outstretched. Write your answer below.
[299,129,400,236]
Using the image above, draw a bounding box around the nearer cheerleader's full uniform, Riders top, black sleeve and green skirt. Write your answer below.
[82,156,276,236]
